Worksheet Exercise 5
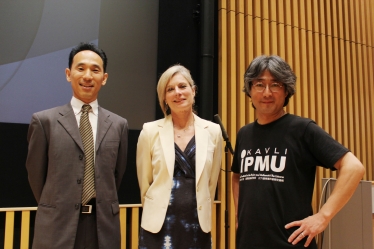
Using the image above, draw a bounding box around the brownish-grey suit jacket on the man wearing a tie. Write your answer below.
[26,103,128,249]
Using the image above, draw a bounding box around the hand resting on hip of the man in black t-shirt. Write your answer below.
[285,213,329,247]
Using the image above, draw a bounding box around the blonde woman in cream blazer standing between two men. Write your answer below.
[136,65,222,249]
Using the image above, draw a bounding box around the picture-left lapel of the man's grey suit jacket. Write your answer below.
[58,103,84,151]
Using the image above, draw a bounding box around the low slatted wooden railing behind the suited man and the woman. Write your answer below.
[0,201,220,249]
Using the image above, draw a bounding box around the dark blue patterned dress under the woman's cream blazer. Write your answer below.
[139,136,211,249]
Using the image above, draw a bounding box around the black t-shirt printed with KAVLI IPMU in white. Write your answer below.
[231,114,349,249]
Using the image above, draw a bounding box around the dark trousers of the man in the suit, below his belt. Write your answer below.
[74,201,99,249]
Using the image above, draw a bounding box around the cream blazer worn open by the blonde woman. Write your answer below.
[136,115,222,233]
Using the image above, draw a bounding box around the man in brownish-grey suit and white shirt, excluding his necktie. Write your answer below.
[26,43,128,249]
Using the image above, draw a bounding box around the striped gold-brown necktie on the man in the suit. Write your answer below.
[79,105,95,205]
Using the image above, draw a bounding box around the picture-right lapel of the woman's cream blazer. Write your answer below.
[194,115,209,185]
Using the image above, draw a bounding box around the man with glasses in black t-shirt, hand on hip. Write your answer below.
[231,56,365,249]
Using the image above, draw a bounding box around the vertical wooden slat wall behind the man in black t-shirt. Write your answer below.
[219,0,374,248]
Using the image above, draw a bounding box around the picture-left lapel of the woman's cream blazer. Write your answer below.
[158,115,175,179]
